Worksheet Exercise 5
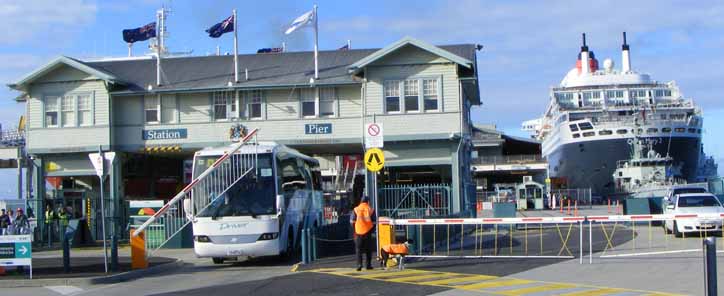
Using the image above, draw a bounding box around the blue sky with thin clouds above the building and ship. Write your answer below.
[0,0,724,198]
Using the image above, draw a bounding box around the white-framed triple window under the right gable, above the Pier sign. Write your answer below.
[383,78,442,113]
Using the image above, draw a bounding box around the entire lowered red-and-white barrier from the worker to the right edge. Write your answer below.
[380,214,724,264]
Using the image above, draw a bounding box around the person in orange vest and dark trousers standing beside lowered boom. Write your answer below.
[349,196,375,271]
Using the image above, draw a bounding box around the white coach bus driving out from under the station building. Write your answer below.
[185,142,323,264]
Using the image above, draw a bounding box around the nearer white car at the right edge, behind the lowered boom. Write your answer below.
[664,193,724,236]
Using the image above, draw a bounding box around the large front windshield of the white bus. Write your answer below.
[194,153,276,218]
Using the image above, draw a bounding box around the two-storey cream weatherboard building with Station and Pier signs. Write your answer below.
[9,37,481,240]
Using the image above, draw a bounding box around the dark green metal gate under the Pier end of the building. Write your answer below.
[378,184,452,218]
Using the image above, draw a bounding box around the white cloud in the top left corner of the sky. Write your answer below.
[0,0,97,45]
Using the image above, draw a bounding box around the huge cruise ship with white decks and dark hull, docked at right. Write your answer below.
[523,32,703,196]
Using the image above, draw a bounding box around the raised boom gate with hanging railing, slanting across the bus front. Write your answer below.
[133,129,258,257]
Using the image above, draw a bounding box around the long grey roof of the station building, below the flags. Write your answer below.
[84,44,475,93]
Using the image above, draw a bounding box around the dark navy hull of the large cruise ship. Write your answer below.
[546,137,701,196]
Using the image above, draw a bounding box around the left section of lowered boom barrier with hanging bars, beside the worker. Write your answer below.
[388,217,585,263]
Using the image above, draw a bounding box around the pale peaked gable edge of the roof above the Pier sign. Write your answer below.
[349,36,474,73]
